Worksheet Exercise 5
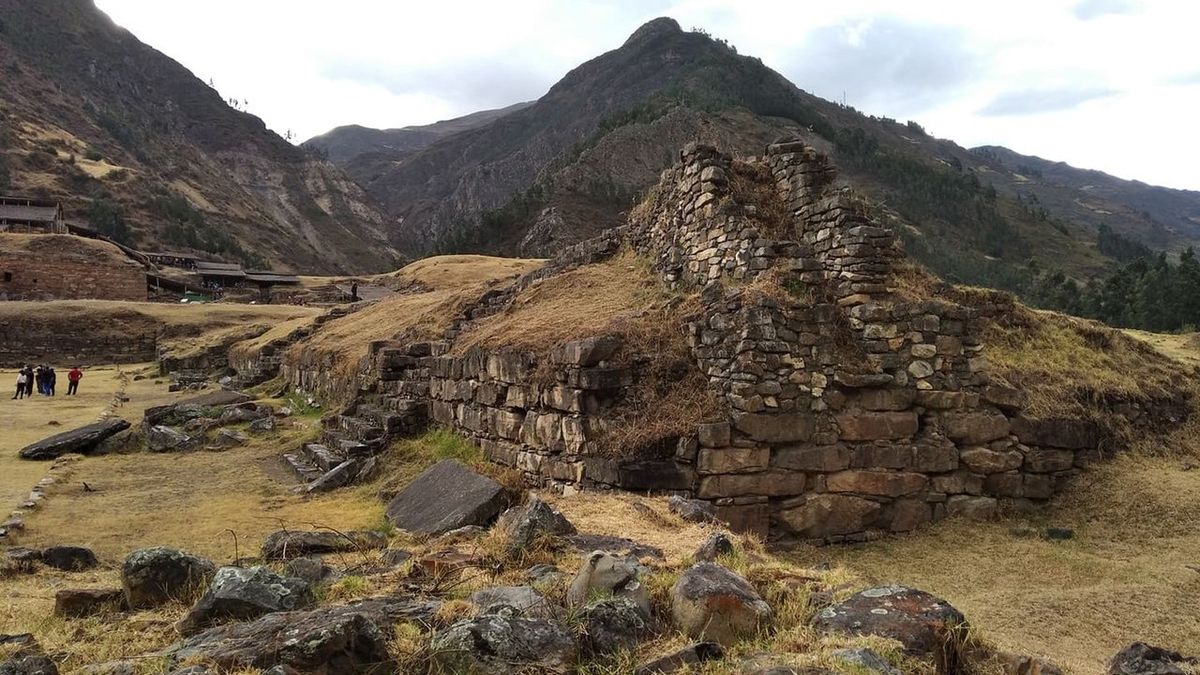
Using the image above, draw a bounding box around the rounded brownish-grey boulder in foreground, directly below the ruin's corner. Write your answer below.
[671,562,773,645]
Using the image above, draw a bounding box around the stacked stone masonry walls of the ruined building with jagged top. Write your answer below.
[272,143,1102,543]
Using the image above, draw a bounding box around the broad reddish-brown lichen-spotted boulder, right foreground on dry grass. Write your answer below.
[814,586,967,658]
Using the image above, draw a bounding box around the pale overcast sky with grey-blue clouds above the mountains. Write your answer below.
[96,0,1200,190]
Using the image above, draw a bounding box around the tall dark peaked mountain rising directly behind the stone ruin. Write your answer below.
[347,18,1196,291]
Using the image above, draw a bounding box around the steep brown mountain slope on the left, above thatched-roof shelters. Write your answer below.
[0,0,396,273]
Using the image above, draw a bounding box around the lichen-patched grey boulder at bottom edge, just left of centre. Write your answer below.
[432,608,577,675]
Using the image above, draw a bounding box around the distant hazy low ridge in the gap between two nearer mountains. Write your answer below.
[302,103,530,167]
